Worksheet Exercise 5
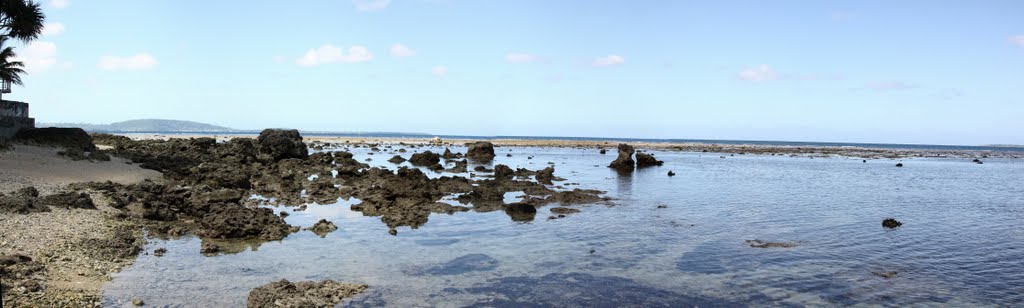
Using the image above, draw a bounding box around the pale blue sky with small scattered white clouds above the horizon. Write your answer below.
[4,0,1024,144]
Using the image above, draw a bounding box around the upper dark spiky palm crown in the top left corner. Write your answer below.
[0,0,46,42]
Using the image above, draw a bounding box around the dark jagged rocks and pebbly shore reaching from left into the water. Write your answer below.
[0,130,609,306]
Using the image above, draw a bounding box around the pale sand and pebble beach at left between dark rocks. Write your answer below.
[0,144,162,307]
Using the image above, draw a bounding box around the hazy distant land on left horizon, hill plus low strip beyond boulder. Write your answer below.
[36,119,431,137]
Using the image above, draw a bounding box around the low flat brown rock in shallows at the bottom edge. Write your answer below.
[247,279,370,308]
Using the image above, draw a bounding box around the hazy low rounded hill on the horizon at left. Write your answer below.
[36,119,241,133]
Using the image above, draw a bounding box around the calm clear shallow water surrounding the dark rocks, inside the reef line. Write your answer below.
[103,147,1024,307]
